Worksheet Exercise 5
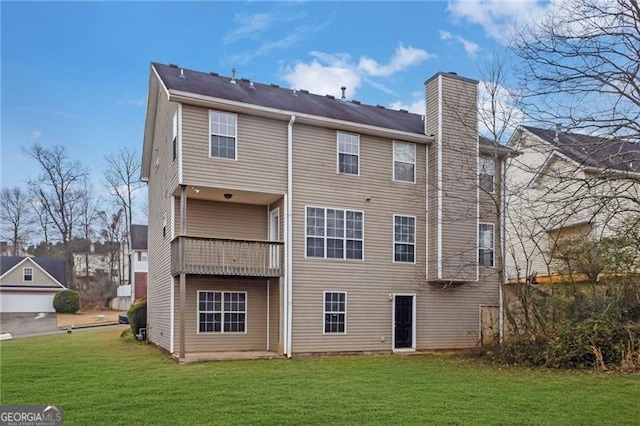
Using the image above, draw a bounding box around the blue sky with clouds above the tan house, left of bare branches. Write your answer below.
[0,0,545,187]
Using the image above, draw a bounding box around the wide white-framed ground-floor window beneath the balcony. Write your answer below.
[198,291,247,333]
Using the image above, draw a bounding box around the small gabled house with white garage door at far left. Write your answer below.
[0,256,66,313]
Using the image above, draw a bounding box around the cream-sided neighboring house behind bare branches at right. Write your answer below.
[505,126,640,283]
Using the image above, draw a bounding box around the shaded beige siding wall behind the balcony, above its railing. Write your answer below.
[175,198,269,240]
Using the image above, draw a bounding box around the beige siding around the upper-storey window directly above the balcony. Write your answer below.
[182,105,287,194]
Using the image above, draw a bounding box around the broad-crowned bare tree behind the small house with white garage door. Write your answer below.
[24,144,88,288]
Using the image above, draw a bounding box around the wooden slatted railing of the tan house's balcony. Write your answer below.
[171,236,283,277]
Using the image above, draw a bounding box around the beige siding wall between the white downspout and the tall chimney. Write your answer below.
[292,125,426,354]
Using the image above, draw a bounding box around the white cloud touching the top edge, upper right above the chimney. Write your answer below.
[447,0,554,43]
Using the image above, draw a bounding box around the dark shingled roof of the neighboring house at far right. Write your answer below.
[523,126,640,173]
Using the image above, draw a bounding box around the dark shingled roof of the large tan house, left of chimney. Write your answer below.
[151,62,424,135]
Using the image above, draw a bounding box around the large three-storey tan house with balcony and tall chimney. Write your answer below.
[142,63,508,361]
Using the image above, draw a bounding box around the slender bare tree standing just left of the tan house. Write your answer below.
[104,148,144,284]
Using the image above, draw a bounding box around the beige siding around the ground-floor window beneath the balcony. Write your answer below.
[185,277,268,352]
